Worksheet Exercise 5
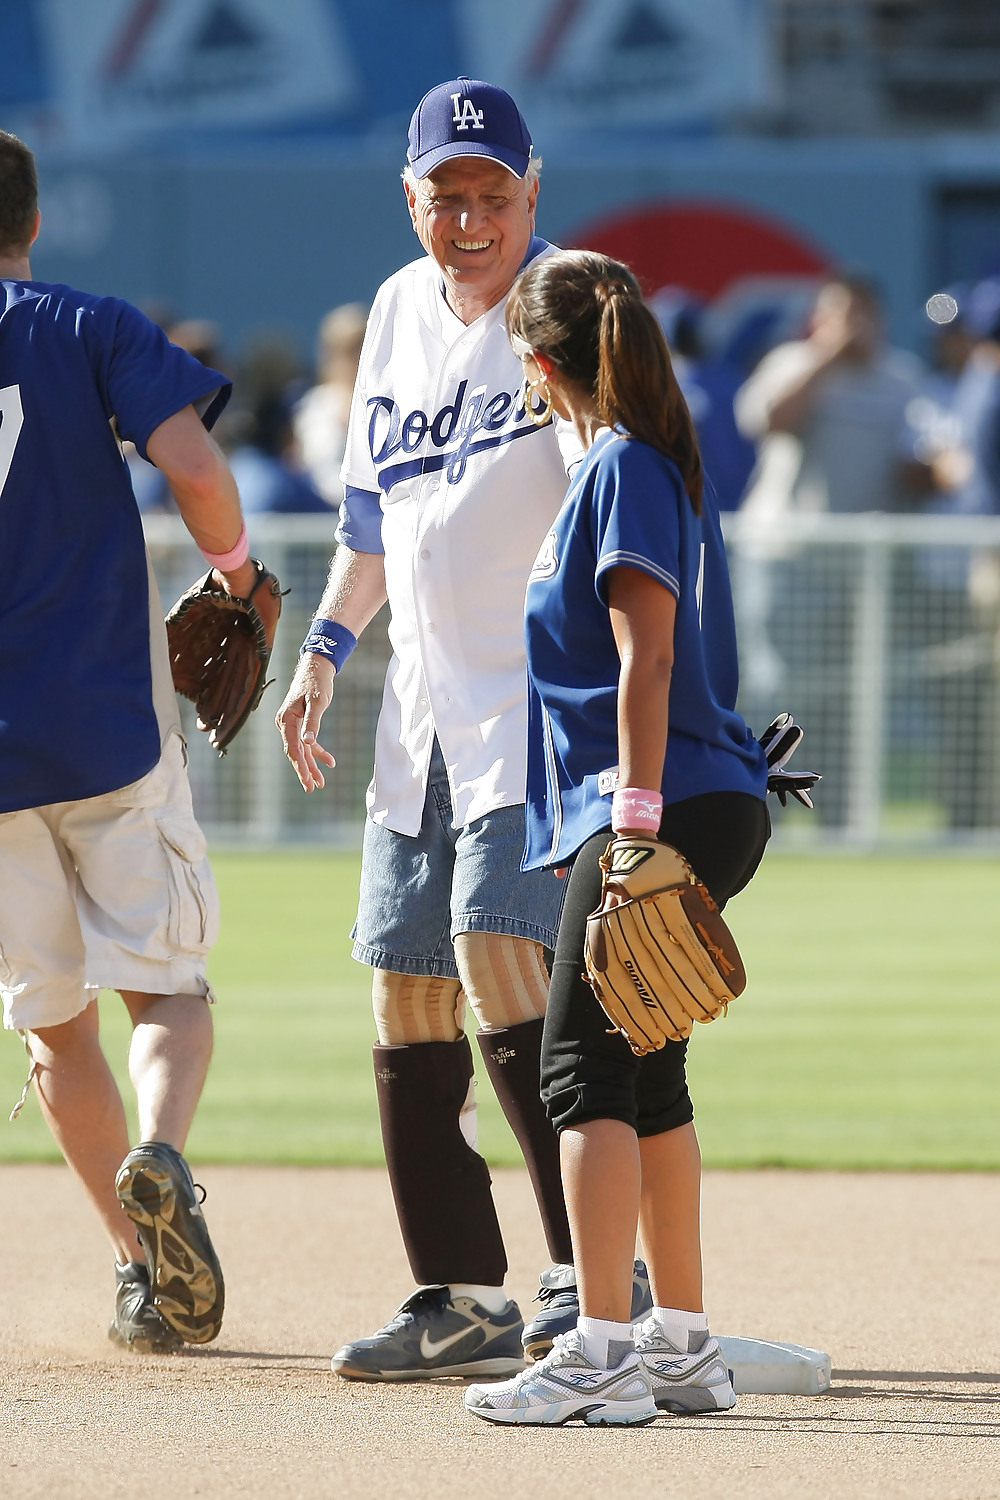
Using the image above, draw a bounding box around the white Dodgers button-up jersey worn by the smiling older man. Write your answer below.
[342,240,582,834]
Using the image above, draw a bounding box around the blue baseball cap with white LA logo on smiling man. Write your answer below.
[406,78,531,177]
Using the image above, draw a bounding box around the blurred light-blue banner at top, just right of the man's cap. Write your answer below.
[460,0,772,137]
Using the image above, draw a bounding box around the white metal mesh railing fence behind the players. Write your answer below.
[145,513,1000,851]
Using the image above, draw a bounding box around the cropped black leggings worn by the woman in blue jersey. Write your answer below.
[541,792,771,1136]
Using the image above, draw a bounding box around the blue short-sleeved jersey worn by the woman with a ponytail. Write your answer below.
[523,431,768,870]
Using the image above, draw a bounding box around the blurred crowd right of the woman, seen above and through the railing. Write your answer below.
[657,275,1000,830]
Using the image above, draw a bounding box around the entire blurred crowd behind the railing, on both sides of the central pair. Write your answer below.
[134,273,1000,830]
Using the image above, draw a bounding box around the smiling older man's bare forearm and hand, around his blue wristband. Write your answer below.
[274,546,385,792]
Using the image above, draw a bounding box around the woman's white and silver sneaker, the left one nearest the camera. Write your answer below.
[465,1329,657,1427]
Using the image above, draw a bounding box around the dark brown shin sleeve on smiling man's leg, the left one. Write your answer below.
[372,1037,507,1287]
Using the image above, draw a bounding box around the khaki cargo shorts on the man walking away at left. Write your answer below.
[0,734,219,1031]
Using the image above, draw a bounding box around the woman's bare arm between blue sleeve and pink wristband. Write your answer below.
[607,567,678,831]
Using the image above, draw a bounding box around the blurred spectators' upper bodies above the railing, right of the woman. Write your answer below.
[654,275,1000,522]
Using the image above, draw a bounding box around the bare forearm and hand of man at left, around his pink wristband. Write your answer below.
[145,407,256,599]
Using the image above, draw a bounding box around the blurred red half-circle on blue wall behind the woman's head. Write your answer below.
[565,201,831,299]
